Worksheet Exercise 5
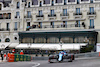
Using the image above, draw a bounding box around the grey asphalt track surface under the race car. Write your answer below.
[0,58,100,67]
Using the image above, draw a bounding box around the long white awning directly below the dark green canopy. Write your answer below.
[16,43,87,50]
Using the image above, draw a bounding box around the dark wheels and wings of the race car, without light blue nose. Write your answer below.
[48,54,75,63]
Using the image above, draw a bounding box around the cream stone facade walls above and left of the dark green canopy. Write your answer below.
[0,0,100,47]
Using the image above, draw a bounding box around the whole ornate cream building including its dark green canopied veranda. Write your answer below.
[0,0,100,49]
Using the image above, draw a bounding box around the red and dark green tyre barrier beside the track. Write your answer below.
[7,54,31,62]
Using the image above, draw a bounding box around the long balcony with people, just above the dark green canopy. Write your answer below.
[28,24,84,30]
